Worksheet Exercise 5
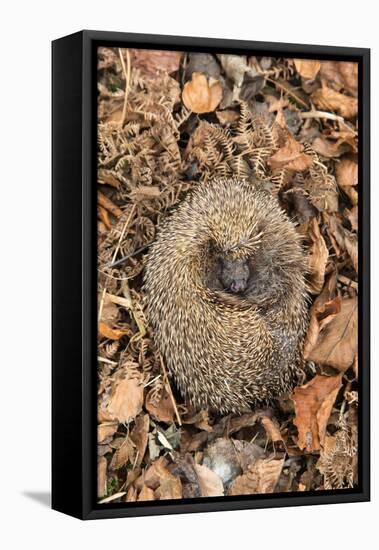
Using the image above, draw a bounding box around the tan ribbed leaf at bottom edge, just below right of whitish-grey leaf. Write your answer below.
[228,458,284,496]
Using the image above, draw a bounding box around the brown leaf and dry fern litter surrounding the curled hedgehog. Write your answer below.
[98,48,359,503]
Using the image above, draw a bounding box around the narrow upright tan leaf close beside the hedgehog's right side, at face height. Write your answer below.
[308,218,329,294]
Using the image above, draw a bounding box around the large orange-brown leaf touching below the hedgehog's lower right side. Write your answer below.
[292,374,342,453]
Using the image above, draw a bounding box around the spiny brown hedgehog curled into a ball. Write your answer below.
[143,178,308,414]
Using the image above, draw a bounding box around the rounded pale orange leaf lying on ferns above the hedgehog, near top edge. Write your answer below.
[182,73,222,113]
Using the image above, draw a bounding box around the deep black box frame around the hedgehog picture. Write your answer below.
[52,30,370,519]
